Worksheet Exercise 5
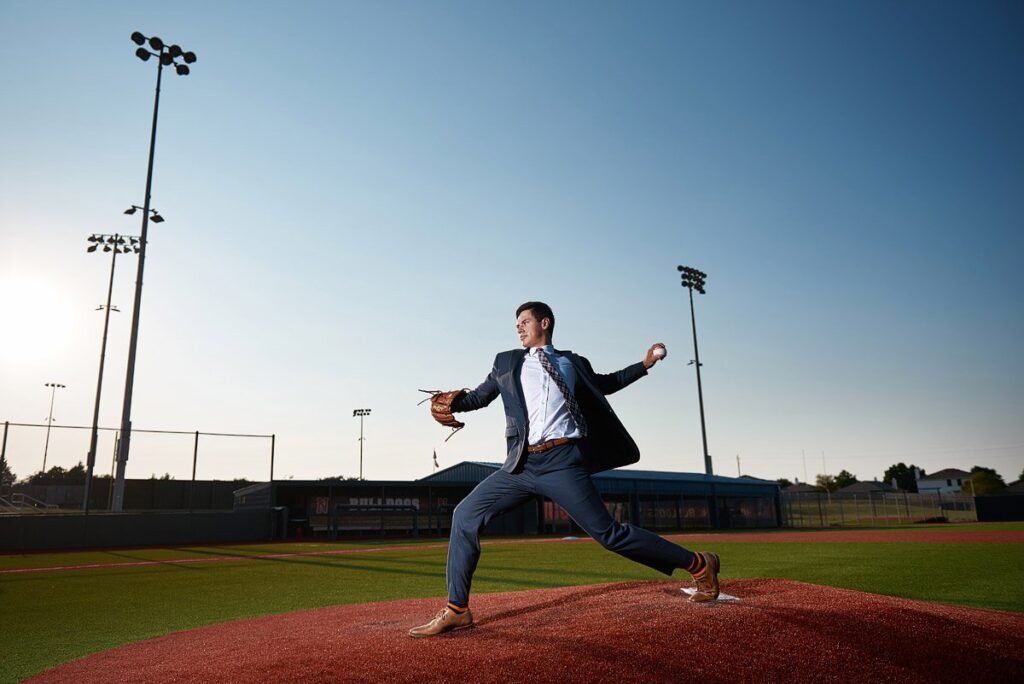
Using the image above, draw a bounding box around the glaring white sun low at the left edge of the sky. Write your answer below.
[0,273,74,365]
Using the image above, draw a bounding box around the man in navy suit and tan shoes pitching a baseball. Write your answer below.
[409,302,720,637]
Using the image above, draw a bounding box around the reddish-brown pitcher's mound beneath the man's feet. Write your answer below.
[30,580,1024,684]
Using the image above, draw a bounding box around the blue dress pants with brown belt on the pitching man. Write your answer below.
[447,442,693,606]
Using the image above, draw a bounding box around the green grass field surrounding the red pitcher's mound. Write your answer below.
[0,523,1024,682]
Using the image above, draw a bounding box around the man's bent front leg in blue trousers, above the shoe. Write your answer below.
[447,470,535,608]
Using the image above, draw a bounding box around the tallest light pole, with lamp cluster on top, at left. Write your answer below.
[111,31,196,511]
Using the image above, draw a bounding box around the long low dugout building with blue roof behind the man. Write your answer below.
[234,462,782,539]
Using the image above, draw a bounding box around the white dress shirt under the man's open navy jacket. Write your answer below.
[519,344,582,444]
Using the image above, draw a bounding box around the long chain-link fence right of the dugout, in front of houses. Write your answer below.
[782,491,977,527]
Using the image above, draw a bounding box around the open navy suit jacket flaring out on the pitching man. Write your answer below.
[452,349,647,473]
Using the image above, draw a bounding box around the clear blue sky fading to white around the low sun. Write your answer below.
[0,0,1024,481]
